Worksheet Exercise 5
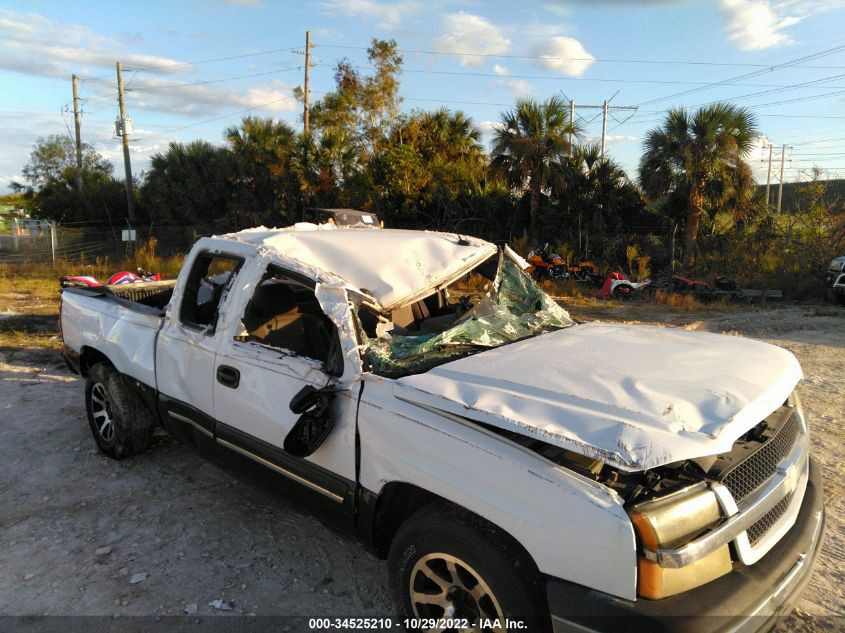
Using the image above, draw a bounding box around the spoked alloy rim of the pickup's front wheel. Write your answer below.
[409,553,505,633]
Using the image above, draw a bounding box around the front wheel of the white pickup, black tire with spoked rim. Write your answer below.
[387,504,550,632]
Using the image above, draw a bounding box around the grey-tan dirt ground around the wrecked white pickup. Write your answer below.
[0,297,845,631]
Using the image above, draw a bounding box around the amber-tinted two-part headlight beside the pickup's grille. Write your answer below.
[628,483,732,599]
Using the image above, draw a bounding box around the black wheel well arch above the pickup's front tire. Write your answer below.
[373,482,537,569]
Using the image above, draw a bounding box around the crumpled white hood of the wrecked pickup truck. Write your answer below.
[394,323,802,471]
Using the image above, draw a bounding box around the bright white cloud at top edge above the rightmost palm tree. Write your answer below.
[719,0,803,50]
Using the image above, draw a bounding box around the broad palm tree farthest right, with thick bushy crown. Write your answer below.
[639,103,757,267]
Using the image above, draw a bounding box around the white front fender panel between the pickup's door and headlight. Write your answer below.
[358,380,636,600]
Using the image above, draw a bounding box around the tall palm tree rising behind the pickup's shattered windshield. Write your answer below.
[490,97,578,242]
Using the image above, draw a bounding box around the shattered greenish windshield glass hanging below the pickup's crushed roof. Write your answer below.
[364,251,573,376]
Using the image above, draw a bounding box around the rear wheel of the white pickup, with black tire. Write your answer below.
[85,363,155,459]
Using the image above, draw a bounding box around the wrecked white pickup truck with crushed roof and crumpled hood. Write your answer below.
[60,224,824,631]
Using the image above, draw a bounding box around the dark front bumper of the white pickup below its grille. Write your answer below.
[546,459,825,633]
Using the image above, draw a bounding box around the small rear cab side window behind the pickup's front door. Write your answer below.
[179,252,244,336]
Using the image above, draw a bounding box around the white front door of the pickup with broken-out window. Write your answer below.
[213,265,358,527]
